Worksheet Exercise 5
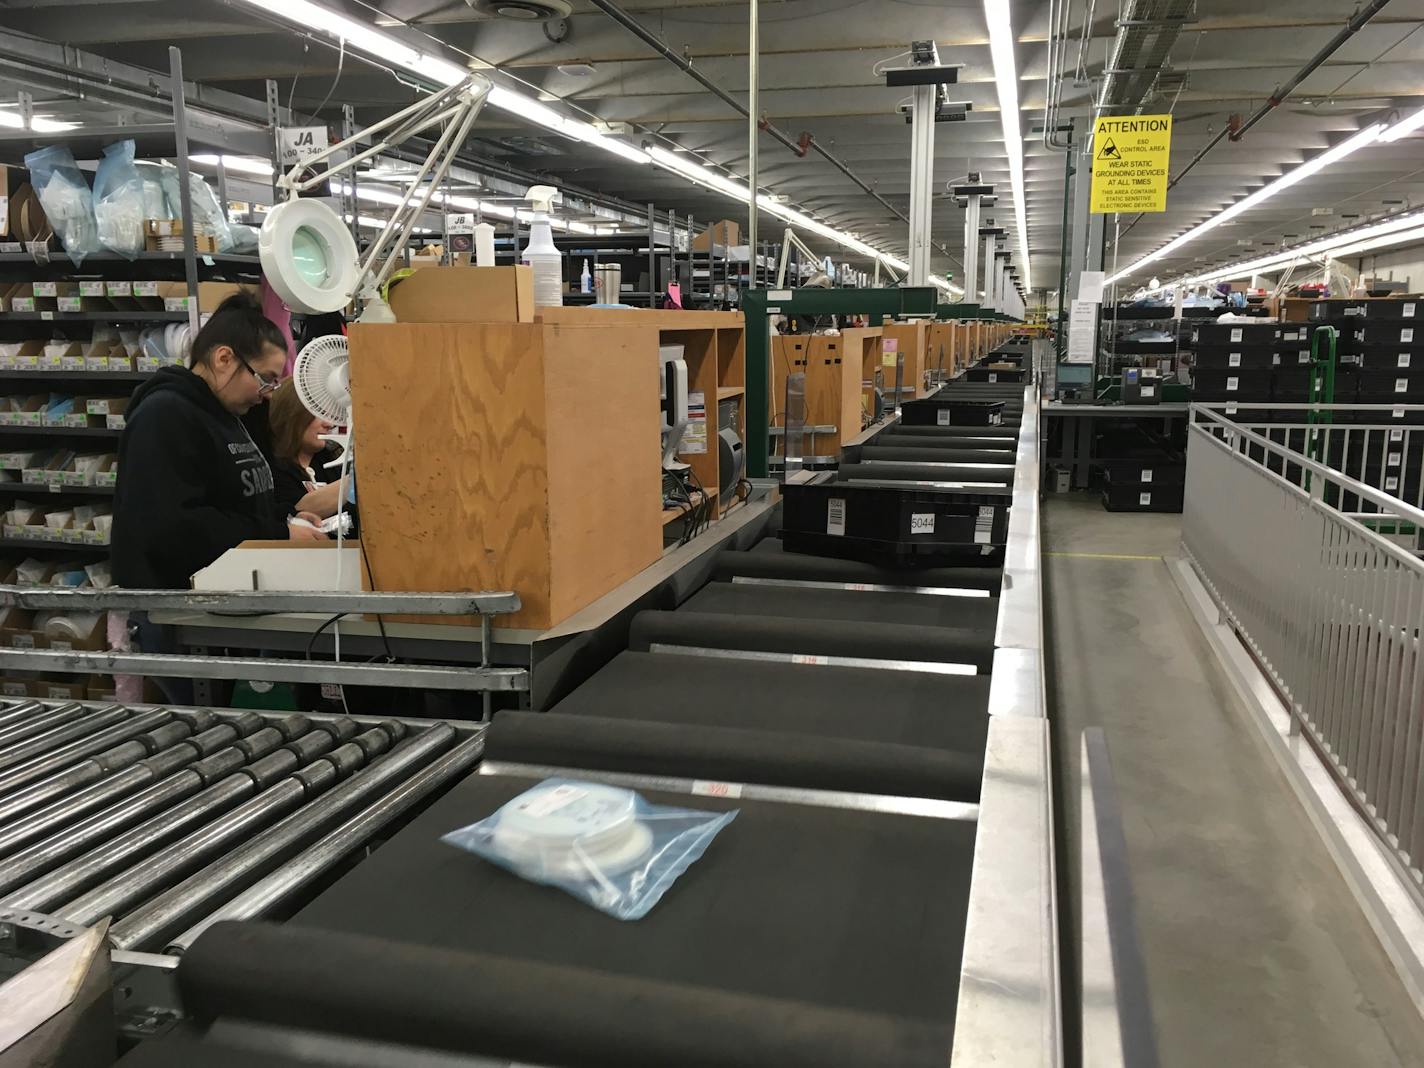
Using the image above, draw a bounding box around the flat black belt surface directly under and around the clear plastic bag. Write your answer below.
[286,776,974,1048]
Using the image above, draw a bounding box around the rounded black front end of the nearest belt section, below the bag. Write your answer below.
[124,911,947,1068]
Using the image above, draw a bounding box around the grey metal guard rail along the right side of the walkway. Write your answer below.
[1182,404,1424,894]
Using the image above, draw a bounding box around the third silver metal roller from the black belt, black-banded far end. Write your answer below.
[56,728,390,926]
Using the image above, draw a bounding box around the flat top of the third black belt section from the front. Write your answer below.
[684,582,998,634]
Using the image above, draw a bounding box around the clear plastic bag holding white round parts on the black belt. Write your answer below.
[441,779,736,920]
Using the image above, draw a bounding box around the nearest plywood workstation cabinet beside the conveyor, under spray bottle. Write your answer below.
[350,308,740,629]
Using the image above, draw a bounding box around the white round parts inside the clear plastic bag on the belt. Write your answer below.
[490,783,652,879]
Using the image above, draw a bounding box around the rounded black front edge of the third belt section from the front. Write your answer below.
[628,609,994,672]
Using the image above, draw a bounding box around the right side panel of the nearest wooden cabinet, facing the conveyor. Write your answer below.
[544,326,663,625]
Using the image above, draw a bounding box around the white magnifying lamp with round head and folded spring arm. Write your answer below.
[258,74,490,322]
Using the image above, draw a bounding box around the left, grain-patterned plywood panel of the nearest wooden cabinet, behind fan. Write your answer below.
[350,323,550,627]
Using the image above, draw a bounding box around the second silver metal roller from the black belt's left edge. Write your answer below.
[118,725,461,950]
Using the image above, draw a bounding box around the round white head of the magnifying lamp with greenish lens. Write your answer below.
[258,201,360,315]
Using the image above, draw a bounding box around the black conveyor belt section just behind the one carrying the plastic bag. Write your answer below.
[486,652,988,800]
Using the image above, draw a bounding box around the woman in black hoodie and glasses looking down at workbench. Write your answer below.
[111,293,325,702]
